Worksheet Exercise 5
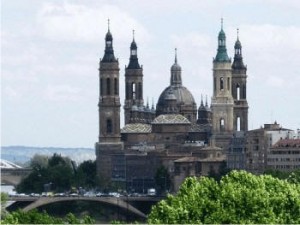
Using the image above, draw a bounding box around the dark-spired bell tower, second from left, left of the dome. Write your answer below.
[124,31,144,125]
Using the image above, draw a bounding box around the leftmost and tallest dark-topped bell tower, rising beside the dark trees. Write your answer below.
[95,21,124,185]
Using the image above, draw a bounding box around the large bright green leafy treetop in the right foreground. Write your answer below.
[148,171,300,224]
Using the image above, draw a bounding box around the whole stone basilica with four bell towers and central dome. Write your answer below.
[95,22,248,193]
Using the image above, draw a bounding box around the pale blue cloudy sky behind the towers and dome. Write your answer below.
[1,0,300,148]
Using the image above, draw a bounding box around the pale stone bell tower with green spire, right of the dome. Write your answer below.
[211,19,234,147]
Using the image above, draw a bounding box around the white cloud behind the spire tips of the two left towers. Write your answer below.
[37,2,150,42]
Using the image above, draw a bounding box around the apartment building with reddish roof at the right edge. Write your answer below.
[267,139,300,171]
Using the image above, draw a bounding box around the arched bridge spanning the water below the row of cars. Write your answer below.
[8,196,163,219]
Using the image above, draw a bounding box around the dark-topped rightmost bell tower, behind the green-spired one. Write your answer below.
[232,29,249,131]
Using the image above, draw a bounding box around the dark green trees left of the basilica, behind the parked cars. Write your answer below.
[16,154,96,194]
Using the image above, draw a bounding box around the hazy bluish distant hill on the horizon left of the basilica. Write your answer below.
[1,146,96,164]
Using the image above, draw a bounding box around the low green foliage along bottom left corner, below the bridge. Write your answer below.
[1,209,95,224]
